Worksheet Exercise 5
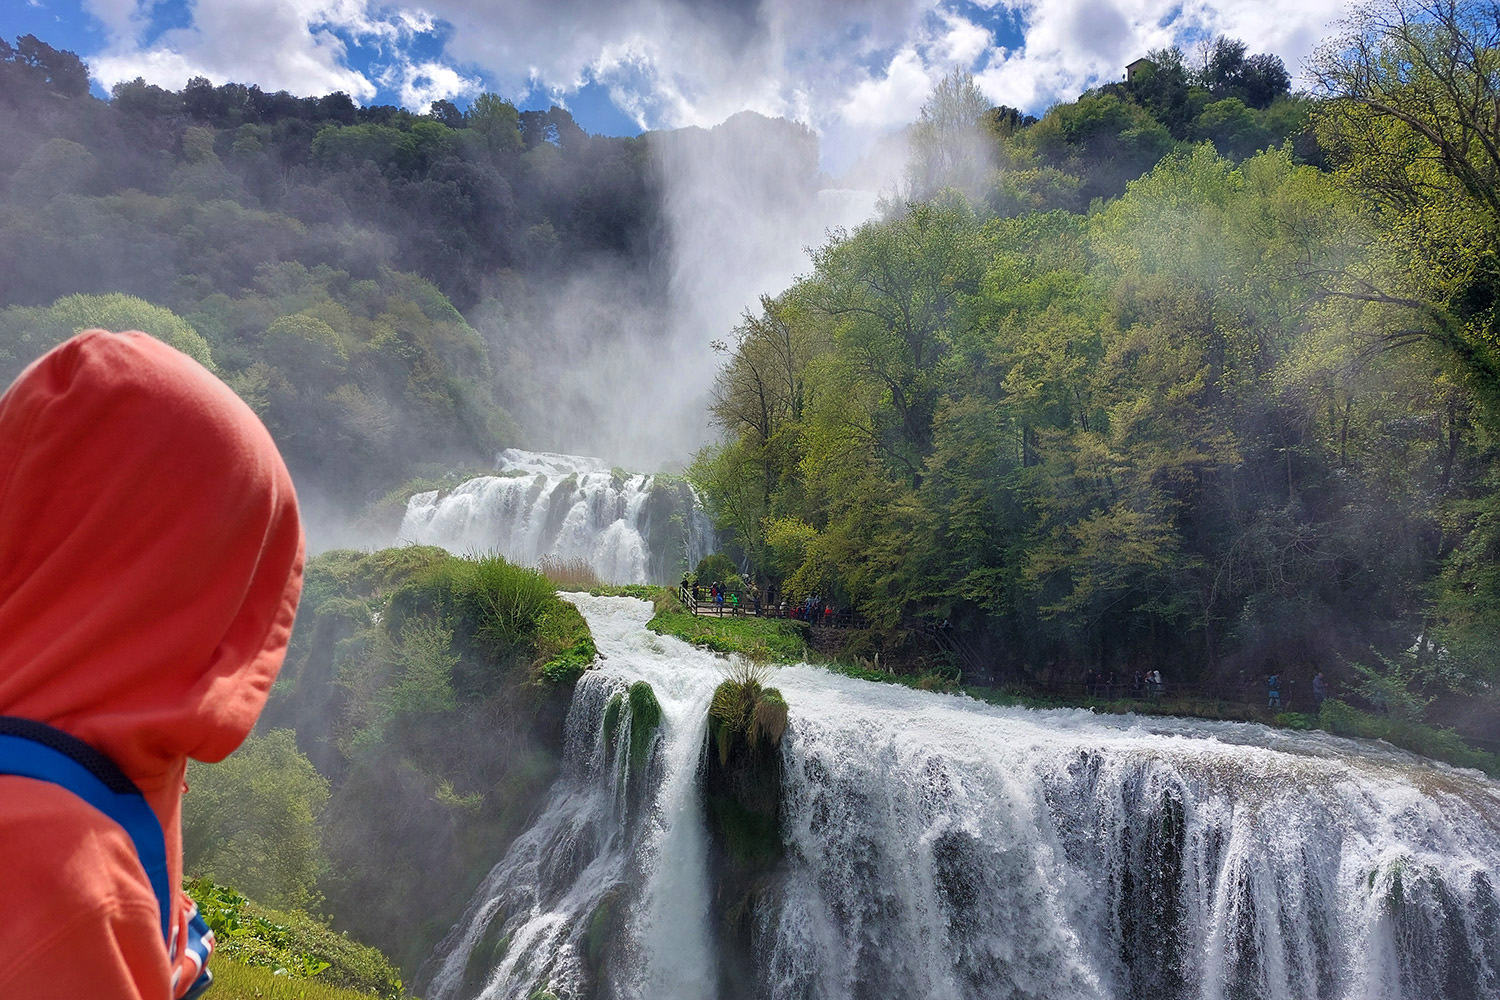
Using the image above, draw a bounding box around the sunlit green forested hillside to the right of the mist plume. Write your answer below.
[693,15,1500,732]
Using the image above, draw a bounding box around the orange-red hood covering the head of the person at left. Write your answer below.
[0,330,303,791]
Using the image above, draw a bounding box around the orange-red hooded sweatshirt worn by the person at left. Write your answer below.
[0,330,303,1000]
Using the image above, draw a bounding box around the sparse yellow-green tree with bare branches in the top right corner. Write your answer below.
[1313,0,1500,424]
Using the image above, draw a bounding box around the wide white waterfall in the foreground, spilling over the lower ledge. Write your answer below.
[423,597,1500,1000]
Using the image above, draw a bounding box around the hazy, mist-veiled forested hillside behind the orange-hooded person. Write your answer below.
[0,36,672,513]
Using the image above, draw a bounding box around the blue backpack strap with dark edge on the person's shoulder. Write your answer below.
[0,715,173,948]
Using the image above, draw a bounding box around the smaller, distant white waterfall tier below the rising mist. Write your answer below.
[398,448,713,583]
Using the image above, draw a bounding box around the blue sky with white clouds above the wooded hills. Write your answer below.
[0,0,1341,147]
